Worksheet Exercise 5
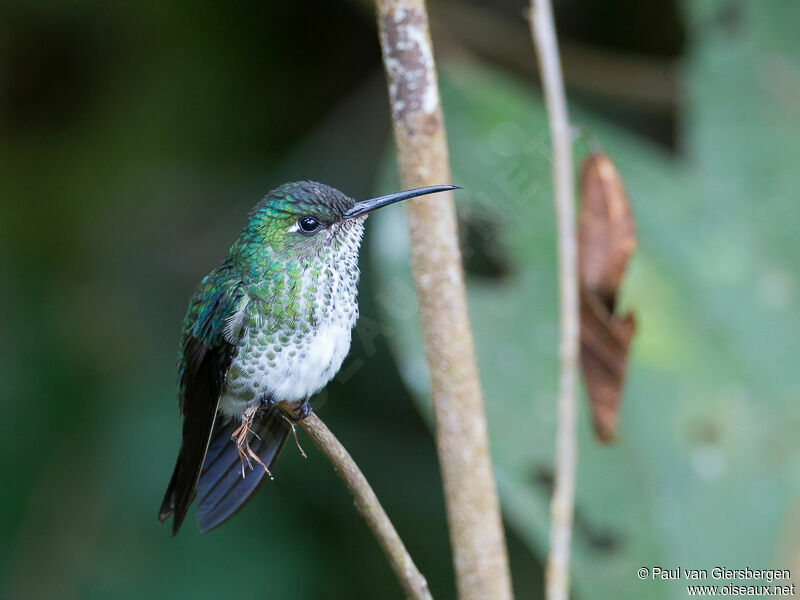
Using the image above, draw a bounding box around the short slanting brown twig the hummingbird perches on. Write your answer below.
[290,412,431,600]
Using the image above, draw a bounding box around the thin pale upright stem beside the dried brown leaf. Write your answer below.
[531,0,580,600]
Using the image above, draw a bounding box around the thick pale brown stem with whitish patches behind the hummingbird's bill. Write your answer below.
[377,0,511,600]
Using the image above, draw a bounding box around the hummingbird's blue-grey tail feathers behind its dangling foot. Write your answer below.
[196,408,289,532]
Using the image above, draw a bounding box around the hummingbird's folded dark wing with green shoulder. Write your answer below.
[158,272,242,534]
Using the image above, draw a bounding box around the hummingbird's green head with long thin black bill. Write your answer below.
[243,181,458,260]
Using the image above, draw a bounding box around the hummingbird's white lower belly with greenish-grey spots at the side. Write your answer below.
[219,319,352,417]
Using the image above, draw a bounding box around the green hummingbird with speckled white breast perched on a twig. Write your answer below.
[158,181,459,535]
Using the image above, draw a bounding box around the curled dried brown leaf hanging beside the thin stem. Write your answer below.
[578,152,636,442]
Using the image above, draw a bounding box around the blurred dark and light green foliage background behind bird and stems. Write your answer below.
[0,0,800,599]
